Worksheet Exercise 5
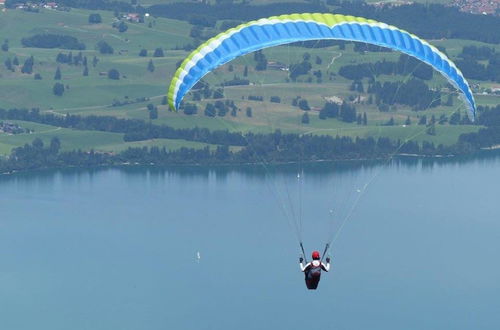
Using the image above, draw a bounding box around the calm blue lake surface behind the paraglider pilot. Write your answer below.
[0,158,500,330]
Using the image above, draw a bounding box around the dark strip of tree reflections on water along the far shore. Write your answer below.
[0,150,500,185]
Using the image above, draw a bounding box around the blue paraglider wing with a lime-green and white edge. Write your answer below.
[168,13,476,121]
